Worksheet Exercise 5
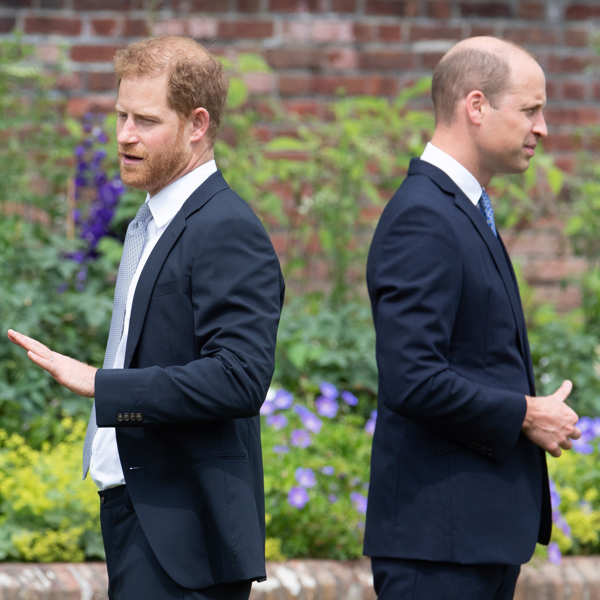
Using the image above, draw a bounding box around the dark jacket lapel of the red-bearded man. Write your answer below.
[123,171,229,368]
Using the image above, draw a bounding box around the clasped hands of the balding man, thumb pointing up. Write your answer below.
[523,380,581,456]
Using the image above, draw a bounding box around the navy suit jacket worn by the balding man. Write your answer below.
[365,159,550,564]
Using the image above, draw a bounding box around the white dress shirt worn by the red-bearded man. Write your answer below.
[90,160,217,490]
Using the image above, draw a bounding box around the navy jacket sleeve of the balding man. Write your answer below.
[367,200,525,460]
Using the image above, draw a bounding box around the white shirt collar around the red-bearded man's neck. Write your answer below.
[146,160,217,229]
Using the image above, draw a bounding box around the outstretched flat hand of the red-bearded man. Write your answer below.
[8,329,98,397]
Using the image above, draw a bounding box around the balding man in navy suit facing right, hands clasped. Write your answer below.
[365,37,579,600]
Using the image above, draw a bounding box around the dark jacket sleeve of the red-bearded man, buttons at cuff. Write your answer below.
[95,209,283,427]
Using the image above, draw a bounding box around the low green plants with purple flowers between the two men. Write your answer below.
[262,386,371,559]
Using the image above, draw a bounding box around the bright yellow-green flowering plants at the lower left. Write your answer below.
[0,419,104,562]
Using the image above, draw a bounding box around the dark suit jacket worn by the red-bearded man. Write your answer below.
[95,172,284,589]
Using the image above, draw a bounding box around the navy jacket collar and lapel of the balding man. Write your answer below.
[408,159,533,382]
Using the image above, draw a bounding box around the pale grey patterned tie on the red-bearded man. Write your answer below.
[83,202,152,479]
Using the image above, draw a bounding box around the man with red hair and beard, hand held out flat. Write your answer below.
[9,37,284,600]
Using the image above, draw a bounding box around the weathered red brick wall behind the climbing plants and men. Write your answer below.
[0,0,600,308]
